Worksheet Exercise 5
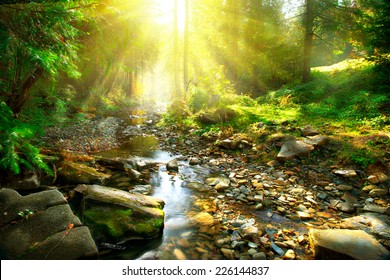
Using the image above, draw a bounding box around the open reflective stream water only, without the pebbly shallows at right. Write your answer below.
[97,121,212,259]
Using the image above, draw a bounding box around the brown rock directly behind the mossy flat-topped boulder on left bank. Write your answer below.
[56,162,110,185]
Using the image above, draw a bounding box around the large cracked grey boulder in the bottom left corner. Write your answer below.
[0,189,97,260]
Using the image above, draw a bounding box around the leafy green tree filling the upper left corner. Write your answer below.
[0,1,91,115]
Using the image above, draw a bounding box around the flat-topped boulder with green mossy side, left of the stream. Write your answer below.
[75,185,165,243]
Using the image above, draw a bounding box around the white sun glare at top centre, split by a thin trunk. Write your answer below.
[154,0,185,32]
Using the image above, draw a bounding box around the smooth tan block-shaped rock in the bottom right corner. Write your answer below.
[309,229,390,260]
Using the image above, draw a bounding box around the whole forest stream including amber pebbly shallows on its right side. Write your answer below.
[93,112,312,260]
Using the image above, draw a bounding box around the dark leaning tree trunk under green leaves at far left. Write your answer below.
[7,67,43,115]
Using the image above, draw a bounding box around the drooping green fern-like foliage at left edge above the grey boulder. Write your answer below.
[0,102,52,174]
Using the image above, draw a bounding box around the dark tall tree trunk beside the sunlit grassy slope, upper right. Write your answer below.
[302,0,314,83]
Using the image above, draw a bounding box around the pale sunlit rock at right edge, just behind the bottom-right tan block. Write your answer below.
[340,213,390,240]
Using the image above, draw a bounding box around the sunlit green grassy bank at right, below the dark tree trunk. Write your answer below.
[258,59,390,126]
